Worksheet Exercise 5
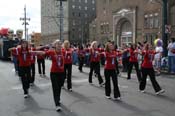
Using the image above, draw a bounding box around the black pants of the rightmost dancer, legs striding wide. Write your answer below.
[140,68,161,92]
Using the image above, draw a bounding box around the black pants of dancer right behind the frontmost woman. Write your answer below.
[64,63,72,89]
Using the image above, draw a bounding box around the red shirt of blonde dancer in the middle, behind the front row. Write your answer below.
[90,48,100,62]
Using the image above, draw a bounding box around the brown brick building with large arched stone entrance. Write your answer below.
[90,0,175,46]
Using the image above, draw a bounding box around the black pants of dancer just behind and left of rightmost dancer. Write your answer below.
[128,62,141,82]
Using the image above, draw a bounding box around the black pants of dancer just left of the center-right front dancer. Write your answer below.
[89,62,103,84]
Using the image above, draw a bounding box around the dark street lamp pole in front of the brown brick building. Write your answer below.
[150,0,168,56]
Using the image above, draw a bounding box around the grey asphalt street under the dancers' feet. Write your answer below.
[0,60,175,116]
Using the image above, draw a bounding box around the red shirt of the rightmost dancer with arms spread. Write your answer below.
[142,50,155,68]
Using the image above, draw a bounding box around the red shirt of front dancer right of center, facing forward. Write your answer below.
[105,51,117,70]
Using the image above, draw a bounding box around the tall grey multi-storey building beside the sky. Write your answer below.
[41,0,96,44]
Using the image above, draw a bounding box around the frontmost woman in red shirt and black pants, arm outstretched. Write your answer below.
[38,40,65,111]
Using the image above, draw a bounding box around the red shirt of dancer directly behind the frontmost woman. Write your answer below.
[62,49,72,64]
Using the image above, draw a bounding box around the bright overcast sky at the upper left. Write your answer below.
[0,0,41,33]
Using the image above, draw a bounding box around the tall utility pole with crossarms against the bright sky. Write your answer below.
[20,5,30,40]
